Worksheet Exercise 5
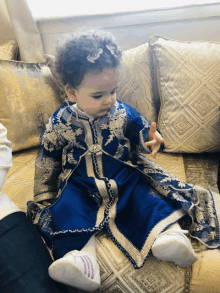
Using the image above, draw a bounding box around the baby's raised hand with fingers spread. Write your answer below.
[145,122,164,159]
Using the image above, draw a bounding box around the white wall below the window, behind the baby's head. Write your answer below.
[37,3,220,55]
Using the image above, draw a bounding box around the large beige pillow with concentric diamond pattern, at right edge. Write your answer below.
[149,35,220,153]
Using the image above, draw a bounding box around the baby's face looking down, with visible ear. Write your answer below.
[65,69,119,117]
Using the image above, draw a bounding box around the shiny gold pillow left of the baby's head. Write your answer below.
[0,60,63,151]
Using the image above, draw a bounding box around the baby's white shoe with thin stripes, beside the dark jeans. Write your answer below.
[48,250,100,292]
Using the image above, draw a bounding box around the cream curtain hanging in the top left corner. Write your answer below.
[0,0,45,62]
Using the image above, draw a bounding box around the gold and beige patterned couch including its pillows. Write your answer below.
[0,35,220,293]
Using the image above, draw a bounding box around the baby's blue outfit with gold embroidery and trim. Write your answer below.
[28,100,219,268]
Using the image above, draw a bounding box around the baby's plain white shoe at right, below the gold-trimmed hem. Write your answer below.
[152,229,197,267]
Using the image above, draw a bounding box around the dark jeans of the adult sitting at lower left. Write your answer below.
[0,212,68,293]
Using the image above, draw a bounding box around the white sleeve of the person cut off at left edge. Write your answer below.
[0,123,12,192]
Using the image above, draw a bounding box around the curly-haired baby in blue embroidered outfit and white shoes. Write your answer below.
[28,29,196,291]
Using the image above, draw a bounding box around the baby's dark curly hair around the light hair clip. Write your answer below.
[55,27,122,89]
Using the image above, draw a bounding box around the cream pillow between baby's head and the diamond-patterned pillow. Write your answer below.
[117,43,157,122]
